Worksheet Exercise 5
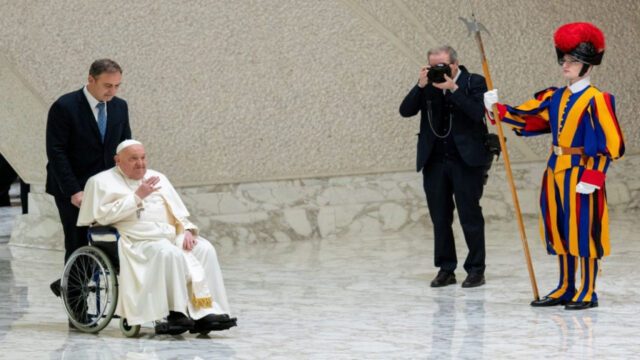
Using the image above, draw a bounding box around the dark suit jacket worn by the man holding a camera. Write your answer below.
[400,66,491,171]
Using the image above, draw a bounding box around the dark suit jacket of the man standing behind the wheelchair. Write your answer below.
[46,89,131,198]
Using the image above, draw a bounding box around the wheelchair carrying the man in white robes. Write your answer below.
[60,226,140,337]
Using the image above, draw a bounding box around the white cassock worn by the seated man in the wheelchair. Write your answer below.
[77,166,231,325]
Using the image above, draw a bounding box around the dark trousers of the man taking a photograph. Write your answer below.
[422,154,485,275]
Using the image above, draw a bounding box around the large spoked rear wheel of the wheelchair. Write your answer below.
[60,246,118,333]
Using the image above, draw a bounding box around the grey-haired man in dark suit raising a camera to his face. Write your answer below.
[400,46,491,287]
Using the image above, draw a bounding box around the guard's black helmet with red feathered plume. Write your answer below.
[553,22,604,65]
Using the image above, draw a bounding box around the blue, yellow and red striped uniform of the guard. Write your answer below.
[498,84,624,301]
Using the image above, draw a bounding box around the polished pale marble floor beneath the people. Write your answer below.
[0,208,640,360]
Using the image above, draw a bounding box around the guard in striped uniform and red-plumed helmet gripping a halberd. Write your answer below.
[484,22,624,310]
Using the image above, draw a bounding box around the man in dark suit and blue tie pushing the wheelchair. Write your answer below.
[46,59,131,296]
